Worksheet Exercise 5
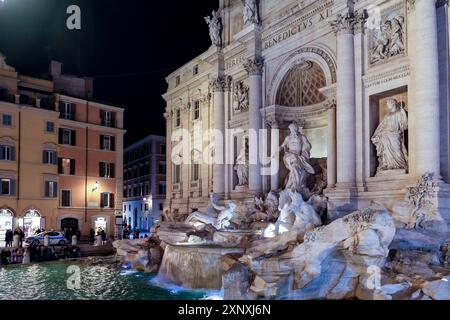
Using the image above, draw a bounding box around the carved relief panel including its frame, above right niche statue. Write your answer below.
[368,4,407,66]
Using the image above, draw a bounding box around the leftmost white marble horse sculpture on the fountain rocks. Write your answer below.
[185,193,237,230]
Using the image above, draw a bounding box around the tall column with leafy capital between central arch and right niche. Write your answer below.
[331,13,356,188]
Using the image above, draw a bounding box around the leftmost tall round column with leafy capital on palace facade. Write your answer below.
[211,76,230,195]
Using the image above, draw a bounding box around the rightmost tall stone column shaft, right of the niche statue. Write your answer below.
[413,0,441,179]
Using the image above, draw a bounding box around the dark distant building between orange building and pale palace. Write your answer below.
[123,135,167,231]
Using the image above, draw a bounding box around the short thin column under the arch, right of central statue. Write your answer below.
[326,100,336,188]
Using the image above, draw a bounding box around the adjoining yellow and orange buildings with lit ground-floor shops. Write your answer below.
[0,56,124,241]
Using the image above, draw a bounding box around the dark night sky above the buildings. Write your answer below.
[0,0,219,144]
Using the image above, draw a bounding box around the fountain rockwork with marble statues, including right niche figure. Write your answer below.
[114,120,450,300]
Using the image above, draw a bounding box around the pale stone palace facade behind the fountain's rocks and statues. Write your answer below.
[164,0,450,228]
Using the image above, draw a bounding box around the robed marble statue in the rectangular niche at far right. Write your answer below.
[372,99,408,172]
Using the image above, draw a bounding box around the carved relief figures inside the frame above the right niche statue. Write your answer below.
[370,16,406,64]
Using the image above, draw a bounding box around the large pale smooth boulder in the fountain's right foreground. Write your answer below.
[290,209,395,296]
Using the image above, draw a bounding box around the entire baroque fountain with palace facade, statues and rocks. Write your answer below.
[116,0,450,300]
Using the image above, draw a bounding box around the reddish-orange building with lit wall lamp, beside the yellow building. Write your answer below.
[55,94,124,236]
